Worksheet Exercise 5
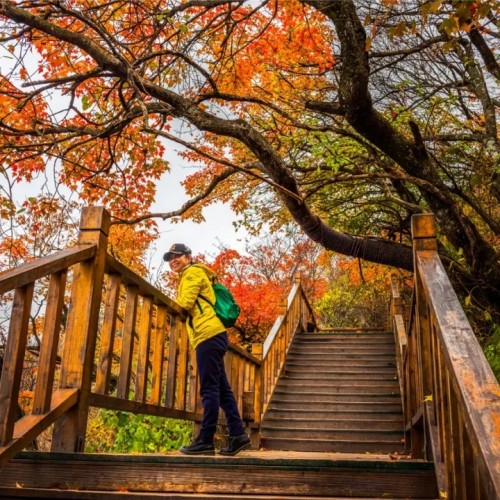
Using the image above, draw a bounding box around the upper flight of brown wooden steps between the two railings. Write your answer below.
[261,331,405,454]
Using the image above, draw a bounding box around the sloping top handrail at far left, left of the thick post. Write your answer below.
[0,245,97,294]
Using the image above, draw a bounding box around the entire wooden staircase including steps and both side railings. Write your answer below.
[0,207,500,500]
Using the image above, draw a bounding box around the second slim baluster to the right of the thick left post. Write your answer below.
[117,286,139,399]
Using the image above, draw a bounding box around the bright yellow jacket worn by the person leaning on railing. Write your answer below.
[175,264,226,349]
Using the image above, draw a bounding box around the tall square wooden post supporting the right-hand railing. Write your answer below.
[409,214,437,458]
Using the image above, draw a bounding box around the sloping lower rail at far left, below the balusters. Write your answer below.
[0,389,78,469]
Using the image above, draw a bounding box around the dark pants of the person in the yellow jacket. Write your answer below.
[196,332,245,441]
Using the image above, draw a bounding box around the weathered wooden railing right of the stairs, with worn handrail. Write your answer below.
[391,214,500,500]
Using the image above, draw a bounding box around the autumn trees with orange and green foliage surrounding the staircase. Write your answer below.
[0,0,500,451]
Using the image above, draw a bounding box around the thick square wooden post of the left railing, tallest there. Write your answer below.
[52,207,110,452]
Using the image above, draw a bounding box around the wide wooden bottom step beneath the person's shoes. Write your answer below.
[0,451,437,500]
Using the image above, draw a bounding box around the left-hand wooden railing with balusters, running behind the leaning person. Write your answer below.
[0,207,314,467]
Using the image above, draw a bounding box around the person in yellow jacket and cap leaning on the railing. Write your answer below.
[163,243,251,455]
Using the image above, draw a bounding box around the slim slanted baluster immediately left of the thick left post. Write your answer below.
[32,270,67,415]
